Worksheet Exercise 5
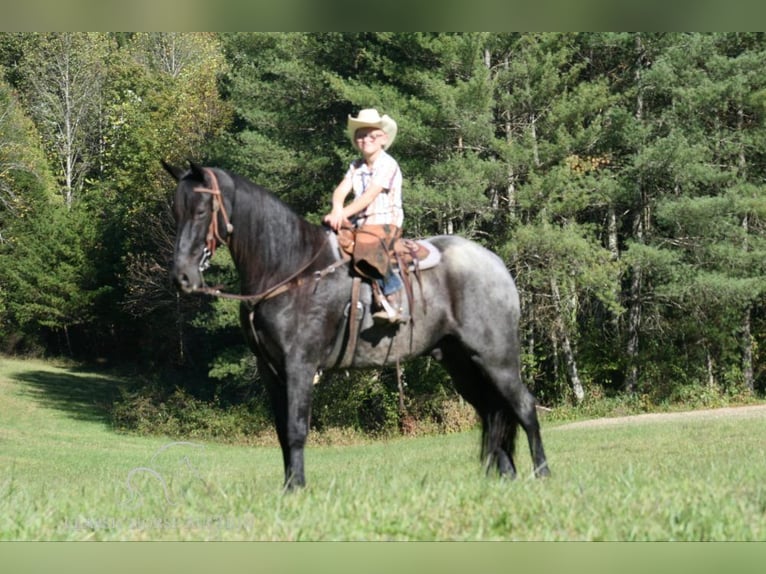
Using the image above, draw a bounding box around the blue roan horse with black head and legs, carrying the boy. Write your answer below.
[163,162,550,488]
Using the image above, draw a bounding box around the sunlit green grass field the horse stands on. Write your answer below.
[0,359,766,540]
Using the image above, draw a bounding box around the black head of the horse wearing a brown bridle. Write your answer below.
[162,162,232,293]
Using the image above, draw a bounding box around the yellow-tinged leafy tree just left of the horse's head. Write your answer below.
[100,33,230,360]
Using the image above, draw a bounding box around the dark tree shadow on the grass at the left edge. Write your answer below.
[11,370,124,424]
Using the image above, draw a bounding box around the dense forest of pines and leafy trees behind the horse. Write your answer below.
[0,33,766,436]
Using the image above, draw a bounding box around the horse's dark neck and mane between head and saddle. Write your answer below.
[219,171,326,292]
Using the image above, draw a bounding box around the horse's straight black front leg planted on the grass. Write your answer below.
[285,365,316,490]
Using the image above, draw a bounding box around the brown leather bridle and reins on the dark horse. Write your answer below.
[194,167,348,304]
